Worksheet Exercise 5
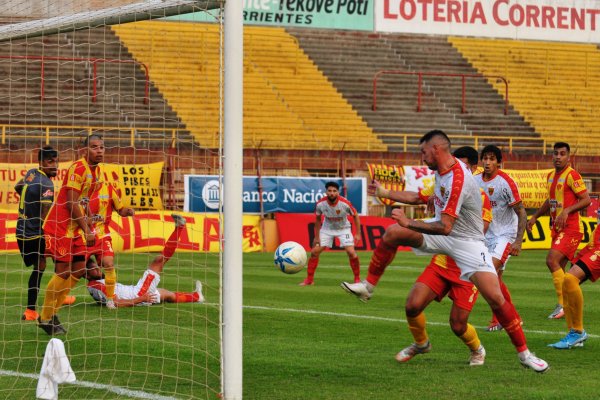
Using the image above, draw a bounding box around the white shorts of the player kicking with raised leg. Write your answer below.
[413,235,496,281]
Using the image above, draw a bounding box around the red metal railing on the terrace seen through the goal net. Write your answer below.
[0,55,150,104]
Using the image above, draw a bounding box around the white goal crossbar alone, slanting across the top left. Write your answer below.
[0,0,224,41]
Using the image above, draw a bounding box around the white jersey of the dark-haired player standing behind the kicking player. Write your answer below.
[475,170,521,242]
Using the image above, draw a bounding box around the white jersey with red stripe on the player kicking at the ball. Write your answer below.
[433,159,482,241]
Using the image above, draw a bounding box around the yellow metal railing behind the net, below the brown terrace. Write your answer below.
[0,124,185,147]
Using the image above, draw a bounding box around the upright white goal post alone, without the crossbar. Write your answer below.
[222,0,244,400]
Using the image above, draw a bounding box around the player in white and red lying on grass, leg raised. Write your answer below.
[87,214,204,307]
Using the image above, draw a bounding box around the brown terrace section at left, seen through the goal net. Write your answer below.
[0,28,191,148]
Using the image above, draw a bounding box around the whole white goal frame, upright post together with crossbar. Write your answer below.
[0,0,243,400]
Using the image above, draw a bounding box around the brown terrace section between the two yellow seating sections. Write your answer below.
[288,28,540,153]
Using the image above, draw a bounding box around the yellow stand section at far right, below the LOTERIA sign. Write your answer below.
[449,37,600,155]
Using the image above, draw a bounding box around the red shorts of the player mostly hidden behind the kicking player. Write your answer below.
[417,263,479,311]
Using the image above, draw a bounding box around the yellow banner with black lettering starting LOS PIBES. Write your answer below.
[102,162,164,210]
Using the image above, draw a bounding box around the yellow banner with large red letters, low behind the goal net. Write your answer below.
[0,211,263,253]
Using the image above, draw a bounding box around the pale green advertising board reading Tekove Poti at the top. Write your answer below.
[166,0,375,31]
